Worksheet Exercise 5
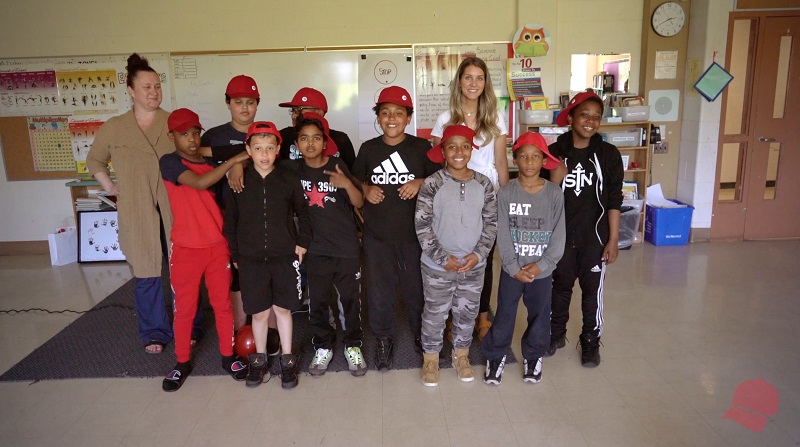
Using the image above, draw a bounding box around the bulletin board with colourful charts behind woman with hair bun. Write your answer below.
[0,53,172,181]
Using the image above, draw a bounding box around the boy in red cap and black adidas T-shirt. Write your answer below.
[353,86,441,369]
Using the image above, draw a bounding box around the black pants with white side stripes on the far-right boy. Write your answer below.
[550,244,606,338]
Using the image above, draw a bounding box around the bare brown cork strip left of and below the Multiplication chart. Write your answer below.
[0,116,77,181]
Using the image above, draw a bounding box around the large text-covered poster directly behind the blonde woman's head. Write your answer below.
[413,43,513,138]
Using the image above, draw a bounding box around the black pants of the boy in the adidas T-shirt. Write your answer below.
[364,233,425,338]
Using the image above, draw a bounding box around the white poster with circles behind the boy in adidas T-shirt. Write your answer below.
[358,52,416,141]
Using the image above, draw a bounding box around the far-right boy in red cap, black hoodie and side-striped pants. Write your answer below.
[547,92,624,368]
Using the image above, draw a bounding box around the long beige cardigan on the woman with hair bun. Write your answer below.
[86,108,175,278]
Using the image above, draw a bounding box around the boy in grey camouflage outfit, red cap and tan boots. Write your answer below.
[414,125,497,386]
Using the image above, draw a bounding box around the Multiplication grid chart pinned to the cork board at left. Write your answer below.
[28,116,75,171]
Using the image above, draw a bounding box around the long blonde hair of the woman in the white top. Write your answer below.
[444,57,500,141]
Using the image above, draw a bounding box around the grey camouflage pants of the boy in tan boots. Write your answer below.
[421,264,485,354]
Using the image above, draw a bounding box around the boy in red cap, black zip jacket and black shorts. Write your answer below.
[223,121,311,388]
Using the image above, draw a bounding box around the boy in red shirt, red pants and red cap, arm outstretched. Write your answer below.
[159,109,247,391]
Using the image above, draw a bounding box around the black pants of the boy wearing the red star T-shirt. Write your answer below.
[305,255,364,349]
